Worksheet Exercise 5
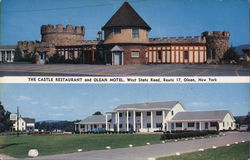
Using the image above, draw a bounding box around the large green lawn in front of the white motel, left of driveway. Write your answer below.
[0,134,161,158]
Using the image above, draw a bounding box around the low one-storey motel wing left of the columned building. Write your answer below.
[75,115,111,132]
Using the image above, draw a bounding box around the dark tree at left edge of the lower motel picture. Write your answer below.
[0,101,13,132]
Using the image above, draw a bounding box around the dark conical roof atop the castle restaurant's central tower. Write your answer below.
[102,2,151,30]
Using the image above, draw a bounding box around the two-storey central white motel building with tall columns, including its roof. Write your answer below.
[106,101,185,132]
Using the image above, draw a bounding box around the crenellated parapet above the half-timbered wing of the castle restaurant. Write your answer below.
[149,36,206,44]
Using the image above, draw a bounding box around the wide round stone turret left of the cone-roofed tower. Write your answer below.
[41,24,85,46]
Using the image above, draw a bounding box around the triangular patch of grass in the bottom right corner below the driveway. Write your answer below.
[157,142,250,160]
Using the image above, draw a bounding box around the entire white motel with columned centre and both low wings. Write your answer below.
[75,101,236,132]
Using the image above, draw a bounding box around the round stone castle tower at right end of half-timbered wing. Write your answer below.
[202,31,230,63]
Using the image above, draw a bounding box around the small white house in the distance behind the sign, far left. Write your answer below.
[13,117,35,131]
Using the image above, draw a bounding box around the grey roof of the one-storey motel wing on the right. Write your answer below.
[172,110,233,121]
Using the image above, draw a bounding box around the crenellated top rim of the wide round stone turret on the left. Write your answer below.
[41,24,85,35]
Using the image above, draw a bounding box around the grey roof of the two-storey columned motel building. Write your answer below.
[114,101,179,111]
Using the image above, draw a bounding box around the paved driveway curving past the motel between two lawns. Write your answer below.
[26,132,250,160]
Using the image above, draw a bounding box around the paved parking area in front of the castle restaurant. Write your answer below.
[0,64,250,76]
